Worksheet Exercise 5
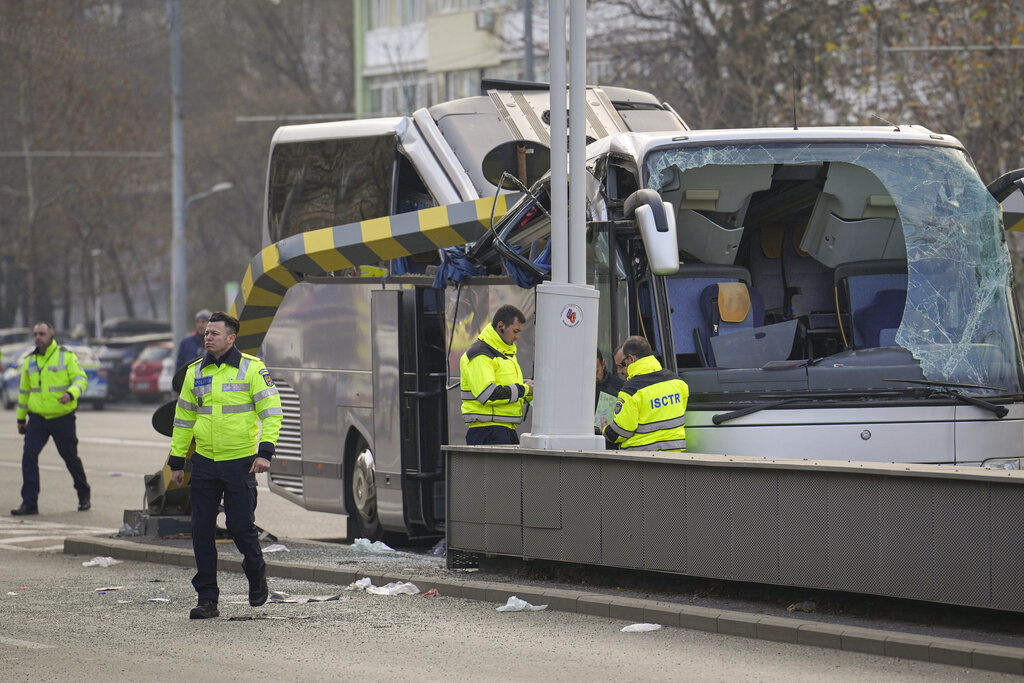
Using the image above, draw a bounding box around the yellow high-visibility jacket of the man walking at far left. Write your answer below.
[17,340,87,422]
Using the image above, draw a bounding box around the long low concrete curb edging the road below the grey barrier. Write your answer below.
[63,537,1024,676]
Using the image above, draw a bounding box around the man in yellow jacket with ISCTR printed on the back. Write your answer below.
[604,336,689,451]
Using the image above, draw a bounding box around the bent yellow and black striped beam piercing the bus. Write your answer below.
[231,195,520,353]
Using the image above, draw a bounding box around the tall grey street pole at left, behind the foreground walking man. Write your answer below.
[167,0,187,350]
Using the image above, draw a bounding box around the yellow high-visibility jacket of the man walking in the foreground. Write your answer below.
[169,346,284,470]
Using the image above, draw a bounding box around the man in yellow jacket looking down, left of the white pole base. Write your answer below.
[459,305,534,445]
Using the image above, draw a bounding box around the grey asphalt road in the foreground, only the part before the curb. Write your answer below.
[0,549,1010,682]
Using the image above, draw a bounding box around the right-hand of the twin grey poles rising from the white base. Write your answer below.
[569,0,587,285]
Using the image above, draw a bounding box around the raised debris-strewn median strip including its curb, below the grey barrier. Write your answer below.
[63,537,1024,676]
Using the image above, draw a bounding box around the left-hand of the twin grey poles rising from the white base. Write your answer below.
[548,0,569,283]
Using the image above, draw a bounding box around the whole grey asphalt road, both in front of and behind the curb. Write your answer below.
[0,404,1015,681]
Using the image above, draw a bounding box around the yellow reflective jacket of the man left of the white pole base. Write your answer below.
[459,323,527,429]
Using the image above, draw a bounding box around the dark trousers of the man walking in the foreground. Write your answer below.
[190,453,266,601]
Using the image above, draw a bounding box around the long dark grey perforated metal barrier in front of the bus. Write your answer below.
[445,445,1024,611]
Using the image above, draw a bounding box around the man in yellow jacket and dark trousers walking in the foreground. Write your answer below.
[169,311,283,618]
